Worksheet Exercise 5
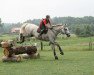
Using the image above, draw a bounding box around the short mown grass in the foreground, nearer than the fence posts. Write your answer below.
[0,51,94,75]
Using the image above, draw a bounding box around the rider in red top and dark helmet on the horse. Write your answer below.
[39,15,51,36]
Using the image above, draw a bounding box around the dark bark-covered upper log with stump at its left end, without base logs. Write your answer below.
[2,42,37,57]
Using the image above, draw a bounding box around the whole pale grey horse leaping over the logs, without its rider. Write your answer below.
[19,23,70,59]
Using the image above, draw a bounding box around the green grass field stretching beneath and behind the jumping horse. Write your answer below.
[0,35,94,75]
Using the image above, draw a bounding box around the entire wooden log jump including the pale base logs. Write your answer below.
[1,42,40,61]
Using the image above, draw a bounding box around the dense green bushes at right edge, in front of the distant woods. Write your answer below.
[74,24,94,37]
